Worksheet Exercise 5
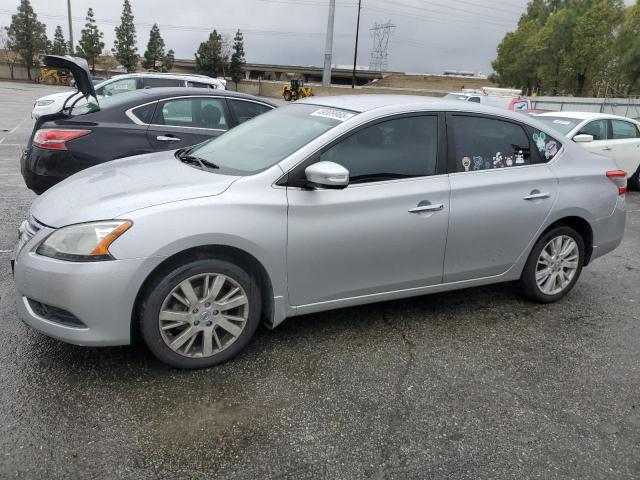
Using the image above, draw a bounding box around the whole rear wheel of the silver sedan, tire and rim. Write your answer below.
[520,227,584,303]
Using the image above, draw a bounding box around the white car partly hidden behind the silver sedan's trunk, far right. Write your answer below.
[536,112,640,190]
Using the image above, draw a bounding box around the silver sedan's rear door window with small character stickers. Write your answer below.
[452,115,532,172]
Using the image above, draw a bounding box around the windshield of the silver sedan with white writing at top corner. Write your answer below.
[189,105,355,174]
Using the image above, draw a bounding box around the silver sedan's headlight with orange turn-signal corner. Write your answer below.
[36,220,133,262]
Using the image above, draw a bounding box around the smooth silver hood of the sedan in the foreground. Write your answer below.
[31,152,239,228]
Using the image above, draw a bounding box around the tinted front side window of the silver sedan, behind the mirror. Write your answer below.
[320,115,438,183]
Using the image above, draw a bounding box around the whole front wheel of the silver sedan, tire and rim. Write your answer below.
[140,260,261,369]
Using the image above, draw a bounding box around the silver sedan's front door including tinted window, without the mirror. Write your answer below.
[287,115,449,306]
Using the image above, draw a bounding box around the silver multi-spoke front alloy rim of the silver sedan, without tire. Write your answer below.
[158,273,249,358]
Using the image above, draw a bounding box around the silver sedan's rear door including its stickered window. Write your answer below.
[443,113,560,283]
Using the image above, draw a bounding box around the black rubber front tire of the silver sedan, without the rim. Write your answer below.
[138,259,262,369]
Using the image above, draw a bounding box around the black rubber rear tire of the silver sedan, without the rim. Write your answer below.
[518,227,585,303]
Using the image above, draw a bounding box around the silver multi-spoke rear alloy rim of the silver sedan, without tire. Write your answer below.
[536,235,580,295]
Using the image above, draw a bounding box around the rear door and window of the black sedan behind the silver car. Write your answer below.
[147,96,230,150]
